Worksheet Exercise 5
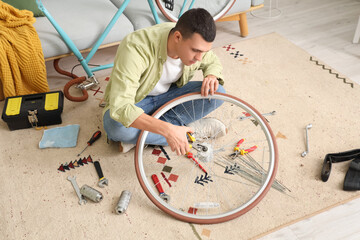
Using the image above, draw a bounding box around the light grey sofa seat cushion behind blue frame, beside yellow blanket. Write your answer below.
[34,0,134,58]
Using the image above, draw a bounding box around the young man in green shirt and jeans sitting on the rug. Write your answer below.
[103,8,225,155]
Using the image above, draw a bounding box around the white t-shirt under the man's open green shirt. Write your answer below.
[149,56,184,96]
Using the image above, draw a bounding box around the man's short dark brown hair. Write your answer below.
[172,8,216,42]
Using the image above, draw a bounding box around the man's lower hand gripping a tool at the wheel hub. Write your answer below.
[165,125,194,155]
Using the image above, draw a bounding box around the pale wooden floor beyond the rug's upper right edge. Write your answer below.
[215,0,360,84]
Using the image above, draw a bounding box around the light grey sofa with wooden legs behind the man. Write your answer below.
[34,0,263,60]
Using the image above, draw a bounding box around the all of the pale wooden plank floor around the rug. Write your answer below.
[47,0,360,240]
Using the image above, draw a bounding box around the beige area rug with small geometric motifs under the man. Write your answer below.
[0,34,360,240]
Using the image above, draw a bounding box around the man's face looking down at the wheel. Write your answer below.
[177,33,212,66]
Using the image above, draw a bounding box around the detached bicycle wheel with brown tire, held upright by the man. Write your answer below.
[135,93,278,224]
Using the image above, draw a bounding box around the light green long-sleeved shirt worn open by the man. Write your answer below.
[104,23,224,127]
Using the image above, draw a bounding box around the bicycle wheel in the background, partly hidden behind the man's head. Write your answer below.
[156,0,236,22]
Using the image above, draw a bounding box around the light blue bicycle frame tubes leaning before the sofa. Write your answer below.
[36,0,160,89]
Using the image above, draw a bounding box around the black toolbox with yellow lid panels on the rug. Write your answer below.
[1,91,64,131]
